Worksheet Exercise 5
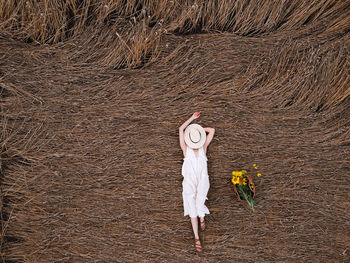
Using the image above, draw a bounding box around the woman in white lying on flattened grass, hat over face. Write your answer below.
[179,112,215,253]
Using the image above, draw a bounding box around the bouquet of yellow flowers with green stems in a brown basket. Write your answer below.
[232,170,260,210]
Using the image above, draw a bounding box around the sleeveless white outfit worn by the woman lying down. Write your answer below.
[182,146,209,217]
